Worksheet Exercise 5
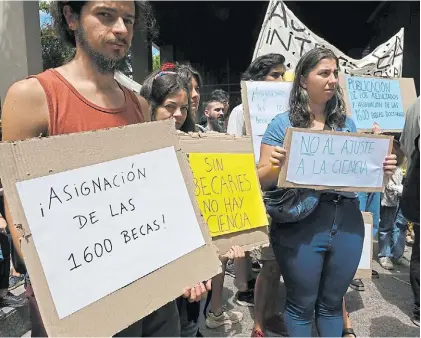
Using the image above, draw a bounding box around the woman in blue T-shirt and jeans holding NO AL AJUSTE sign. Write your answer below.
[258,48,396,337]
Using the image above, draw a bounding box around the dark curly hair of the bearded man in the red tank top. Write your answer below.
[50,1,157,47]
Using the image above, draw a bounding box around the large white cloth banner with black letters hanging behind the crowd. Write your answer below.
[253,0,404,78]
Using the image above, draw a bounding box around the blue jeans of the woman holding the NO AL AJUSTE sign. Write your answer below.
[270,199,364,337]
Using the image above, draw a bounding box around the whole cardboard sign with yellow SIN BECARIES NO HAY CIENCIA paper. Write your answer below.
[178,132,269,255]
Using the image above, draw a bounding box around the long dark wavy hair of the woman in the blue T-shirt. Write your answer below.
[289,47,346,128]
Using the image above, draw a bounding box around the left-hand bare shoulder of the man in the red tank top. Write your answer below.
[2,78,49,141]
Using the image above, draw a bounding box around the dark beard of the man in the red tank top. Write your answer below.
[75,27,126,74]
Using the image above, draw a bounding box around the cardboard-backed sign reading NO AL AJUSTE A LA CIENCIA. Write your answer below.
[278,128,393,191]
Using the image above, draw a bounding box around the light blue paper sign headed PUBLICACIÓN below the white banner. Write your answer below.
[345,76,405,130]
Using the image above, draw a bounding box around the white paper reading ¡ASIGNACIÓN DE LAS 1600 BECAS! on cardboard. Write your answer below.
[16,147,205,318]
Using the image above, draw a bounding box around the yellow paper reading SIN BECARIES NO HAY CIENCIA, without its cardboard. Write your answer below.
[189,153,268,237]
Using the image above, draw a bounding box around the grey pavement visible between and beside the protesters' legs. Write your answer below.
[201,243,420,337]
